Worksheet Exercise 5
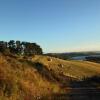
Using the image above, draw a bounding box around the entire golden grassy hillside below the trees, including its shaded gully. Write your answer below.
[0,54,100,100]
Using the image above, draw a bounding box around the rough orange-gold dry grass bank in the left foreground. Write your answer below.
[0,55,60,100]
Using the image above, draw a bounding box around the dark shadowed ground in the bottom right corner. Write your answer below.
[42,76,100,100]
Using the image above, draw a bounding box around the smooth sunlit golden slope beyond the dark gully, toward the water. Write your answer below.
[33,56,100,79]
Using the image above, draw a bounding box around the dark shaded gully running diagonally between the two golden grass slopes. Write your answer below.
[27,61,74,88]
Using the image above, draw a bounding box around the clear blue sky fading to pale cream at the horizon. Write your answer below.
[0,0,100,53]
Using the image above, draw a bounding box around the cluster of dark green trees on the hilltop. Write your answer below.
[0,40,43,55]
